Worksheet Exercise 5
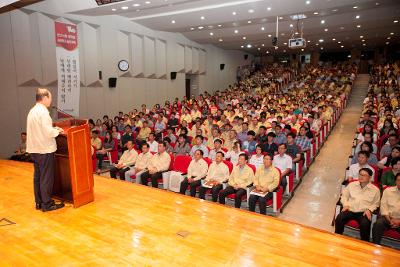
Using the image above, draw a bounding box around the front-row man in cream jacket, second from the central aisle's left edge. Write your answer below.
[219,154,254,208]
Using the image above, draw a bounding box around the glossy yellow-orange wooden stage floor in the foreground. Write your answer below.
[0,160,400,266]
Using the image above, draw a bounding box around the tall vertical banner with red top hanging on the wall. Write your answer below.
[55,21,81,117]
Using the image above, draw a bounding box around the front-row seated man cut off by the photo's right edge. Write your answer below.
[372,173,400,244]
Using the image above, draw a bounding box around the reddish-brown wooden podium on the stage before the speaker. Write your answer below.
[53,118,94,208]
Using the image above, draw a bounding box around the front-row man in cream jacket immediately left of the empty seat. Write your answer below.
[142,142,171,188]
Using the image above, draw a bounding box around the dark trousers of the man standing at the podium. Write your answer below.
[31,153,55,208]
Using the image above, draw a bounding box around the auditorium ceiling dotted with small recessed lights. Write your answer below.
[70,0,400,54]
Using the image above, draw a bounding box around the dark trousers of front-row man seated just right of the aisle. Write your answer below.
[335,211,371,241]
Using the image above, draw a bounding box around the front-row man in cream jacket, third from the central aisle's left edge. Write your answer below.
[199,152,229,202]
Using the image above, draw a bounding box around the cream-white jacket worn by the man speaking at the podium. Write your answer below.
[26,103,59,154]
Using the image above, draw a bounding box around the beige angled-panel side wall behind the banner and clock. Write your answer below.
[0,5,252,158]
